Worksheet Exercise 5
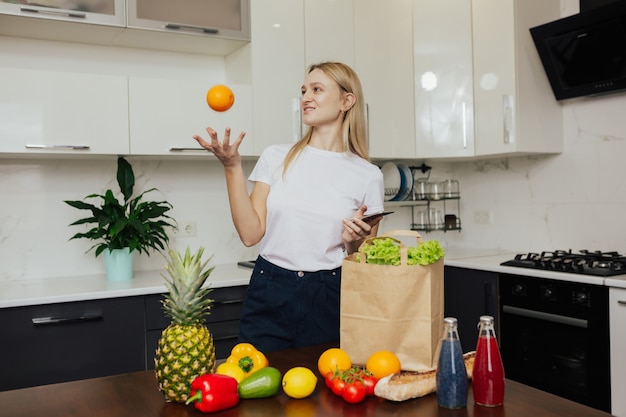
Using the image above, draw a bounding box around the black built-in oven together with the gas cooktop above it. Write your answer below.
[498,252,624,412]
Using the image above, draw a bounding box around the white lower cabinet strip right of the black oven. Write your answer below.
[609,288,626,417]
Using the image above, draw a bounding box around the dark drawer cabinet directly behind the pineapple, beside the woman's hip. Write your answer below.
[146,285,248,369]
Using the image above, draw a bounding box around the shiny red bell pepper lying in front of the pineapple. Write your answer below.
[185,374,239,413]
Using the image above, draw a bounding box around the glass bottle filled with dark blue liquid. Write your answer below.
[437,317,467,408]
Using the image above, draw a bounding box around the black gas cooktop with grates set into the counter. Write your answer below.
[500,249,626,277]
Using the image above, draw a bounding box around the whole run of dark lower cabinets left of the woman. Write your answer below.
[0,286,248,391]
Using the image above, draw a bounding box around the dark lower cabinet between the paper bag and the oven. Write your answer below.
[444,266,499,352]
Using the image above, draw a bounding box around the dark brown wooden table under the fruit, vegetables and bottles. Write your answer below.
[0,345,609,417]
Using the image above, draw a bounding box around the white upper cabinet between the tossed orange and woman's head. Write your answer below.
[225,0,305,155]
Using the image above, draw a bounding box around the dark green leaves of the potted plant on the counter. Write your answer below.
[64,156,176,257]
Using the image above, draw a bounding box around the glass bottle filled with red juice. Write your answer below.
[472,316,504,407]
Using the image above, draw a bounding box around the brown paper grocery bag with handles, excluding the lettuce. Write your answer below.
[340,231,444,371]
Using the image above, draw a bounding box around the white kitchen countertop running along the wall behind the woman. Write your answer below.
[0,248,626,308]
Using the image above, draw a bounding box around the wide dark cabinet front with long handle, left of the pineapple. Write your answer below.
[0,297,146,391]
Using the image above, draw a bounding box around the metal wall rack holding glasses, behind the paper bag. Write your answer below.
[385,164,462,232]
